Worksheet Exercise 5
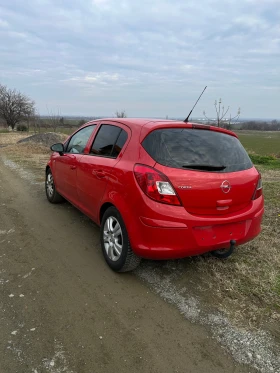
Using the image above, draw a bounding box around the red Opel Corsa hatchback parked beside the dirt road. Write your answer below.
[46,118,264,272]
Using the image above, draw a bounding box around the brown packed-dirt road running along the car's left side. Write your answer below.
[0,158,253,373]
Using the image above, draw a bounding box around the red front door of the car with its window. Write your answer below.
[54,125,95,205]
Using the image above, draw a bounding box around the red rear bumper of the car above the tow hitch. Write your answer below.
[129,197,264,259]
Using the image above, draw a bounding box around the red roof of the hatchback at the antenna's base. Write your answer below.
[84,118,237,137]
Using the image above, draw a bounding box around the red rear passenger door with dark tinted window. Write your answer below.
[77,123,128,222]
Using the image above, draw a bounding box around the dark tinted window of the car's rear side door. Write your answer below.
[91,124,127,158]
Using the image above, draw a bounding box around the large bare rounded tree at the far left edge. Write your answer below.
[0,84,35,130]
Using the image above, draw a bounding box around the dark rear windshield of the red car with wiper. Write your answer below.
[142,128,253,172]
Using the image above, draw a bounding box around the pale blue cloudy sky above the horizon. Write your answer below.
[0,0,280,119]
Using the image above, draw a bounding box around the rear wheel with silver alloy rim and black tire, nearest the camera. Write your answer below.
[100,206,141,272]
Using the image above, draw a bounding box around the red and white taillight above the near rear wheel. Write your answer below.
[134,164,181,206]
